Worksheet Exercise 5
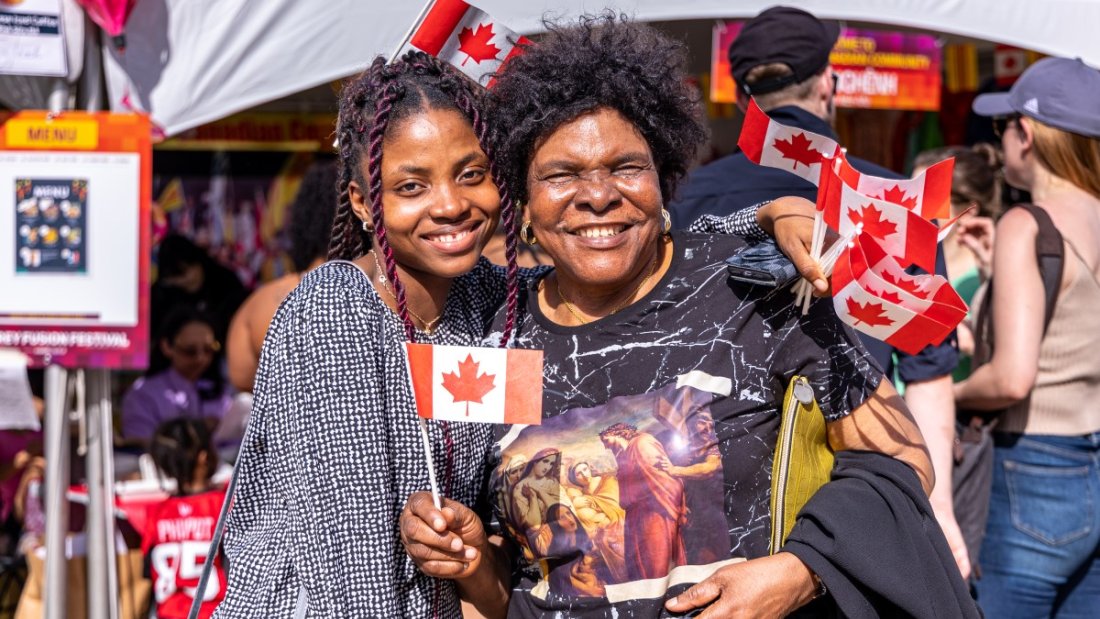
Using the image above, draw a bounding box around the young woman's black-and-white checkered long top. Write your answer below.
[215,259,505,619]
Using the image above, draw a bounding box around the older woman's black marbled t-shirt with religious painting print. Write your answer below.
[491,232,882,619]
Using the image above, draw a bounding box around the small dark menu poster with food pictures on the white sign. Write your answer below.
[15,178,88,274]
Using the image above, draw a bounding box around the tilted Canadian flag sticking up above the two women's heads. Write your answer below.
[397,0,530,86]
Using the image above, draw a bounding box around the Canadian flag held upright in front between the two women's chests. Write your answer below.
[405,343,542,425]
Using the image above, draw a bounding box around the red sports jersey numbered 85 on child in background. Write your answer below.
[142,489,226,619]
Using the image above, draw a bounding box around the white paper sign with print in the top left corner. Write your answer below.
[0,0,68,77]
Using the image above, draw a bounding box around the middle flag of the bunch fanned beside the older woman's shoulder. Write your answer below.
[817,165,939,273]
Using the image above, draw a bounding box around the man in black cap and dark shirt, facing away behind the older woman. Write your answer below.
[669,7,970,576]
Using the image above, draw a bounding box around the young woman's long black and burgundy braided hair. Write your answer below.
[329,52,519,346]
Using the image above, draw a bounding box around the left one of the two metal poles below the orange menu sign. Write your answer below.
[44,365,69,619]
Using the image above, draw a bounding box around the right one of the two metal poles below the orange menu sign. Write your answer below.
[84,369,119,619]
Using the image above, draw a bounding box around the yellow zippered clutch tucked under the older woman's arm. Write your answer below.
[769,376,834,554]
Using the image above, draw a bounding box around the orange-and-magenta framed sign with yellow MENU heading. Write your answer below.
[0,111,152,369]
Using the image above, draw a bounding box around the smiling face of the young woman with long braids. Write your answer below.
[349,109,501,279]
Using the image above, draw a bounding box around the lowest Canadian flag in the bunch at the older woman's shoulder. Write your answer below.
[833,235,966,354]
